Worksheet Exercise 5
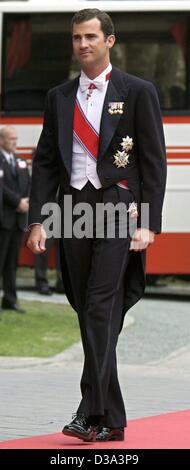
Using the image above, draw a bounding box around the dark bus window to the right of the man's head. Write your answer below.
[110,12,188,110]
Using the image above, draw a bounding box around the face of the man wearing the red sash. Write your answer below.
[72,18,115,68]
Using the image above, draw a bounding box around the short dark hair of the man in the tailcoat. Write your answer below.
[71,8,114,38]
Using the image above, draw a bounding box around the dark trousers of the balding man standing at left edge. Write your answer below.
[0,225,23,306]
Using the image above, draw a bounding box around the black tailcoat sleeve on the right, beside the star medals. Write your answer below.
[136,82,166,233]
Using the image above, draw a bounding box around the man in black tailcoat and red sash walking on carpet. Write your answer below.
[28,9,166,441]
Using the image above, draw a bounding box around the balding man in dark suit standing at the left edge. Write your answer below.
[0,126,30,313]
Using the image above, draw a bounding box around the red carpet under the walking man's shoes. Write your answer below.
[0,410,190,450]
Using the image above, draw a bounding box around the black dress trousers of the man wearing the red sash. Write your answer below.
[63,182,133,427]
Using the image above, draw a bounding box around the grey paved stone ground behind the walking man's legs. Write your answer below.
[0,293,190,440]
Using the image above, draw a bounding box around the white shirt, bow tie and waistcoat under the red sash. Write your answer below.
[70,64,112,190]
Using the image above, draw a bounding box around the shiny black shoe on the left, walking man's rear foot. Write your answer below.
[62,414,97,441]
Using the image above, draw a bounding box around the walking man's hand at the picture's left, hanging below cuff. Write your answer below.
[26,224,47,255]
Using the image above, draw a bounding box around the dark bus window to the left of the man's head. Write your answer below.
[2,14,72,114]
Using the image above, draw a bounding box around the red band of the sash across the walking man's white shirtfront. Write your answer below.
[73,101,99,160]
